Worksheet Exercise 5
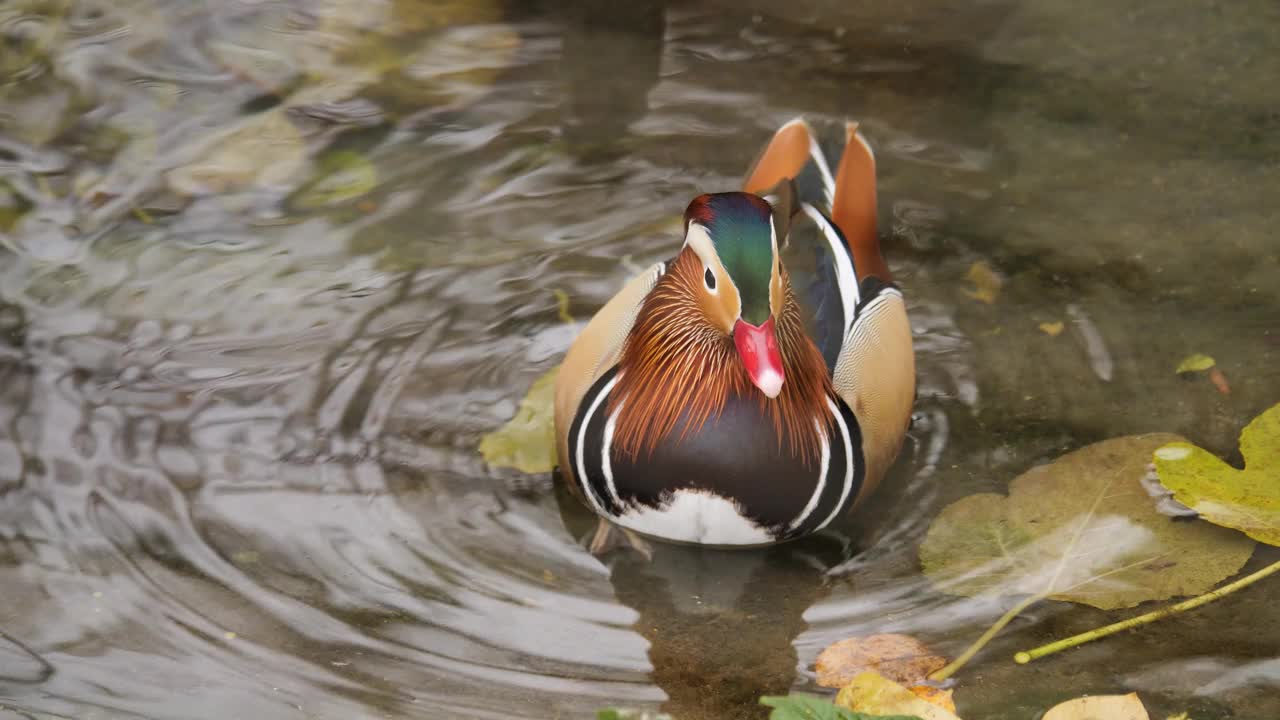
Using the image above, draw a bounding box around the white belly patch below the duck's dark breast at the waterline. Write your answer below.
[613,489,777,546]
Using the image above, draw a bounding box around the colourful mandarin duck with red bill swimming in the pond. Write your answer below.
[554,118,915,551]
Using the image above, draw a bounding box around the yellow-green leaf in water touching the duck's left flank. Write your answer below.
[480,365,559,474]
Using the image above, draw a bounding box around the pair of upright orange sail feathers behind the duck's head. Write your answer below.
[742,118,892,282]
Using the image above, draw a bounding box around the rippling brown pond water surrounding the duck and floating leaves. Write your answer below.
[0,0,1280,720]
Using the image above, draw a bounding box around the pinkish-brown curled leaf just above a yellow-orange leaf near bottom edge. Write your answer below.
[815,633,947,688]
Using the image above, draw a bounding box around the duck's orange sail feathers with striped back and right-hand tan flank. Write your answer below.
[744,119,915,495]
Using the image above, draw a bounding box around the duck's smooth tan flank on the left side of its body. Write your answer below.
[556,263,667,479]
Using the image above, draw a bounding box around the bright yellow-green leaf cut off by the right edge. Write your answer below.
[1155,397,1280,544]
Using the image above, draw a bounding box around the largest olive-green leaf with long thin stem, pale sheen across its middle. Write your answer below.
[920,433,1253,679]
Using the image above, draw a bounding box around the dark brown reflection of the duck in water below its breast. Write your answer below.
[557,483,851,720]
